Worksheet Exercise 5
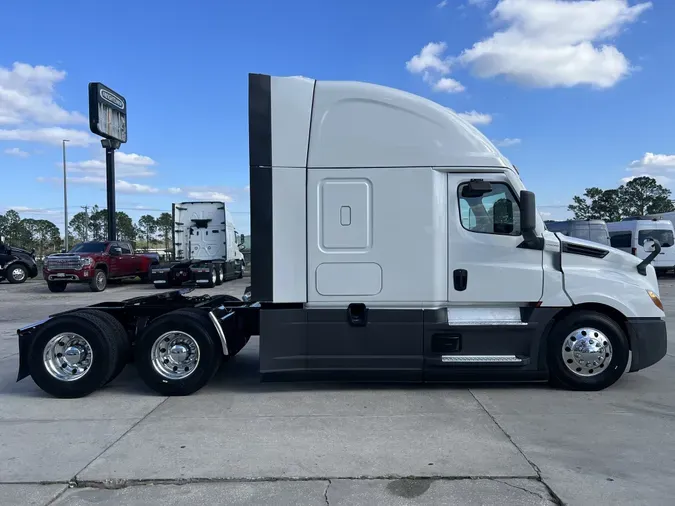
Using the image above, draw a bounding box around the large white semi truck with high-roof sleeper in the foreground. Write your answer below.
[13,74,667,397]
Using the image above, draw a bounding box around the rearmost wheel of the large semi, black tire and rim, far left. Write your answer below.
[28,312,119,398]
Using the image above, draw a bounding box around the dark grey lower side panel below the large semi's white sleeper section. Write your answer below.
[307,304,423,381]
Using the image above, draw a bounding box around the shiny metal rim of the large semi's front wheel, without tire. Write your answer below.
[562,327,613,378]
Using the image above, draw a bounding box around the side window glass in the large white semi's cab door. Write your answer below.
[457,183,521,236]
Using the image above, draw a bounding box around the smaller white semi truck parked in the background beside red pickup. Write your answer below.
[151,202,245,289]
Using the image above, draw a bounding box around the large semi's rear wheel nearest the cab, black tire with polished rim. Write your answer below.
[134,308,223,396]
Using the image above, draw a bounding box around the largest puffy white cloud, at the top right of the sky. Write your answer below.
[458,0,652,88]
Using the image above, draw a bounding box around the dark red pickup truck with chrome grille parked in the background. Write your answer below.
[42,241,159,292]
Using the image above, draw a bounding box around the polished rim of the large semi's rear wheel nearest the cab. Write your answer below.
[150,330,199,380]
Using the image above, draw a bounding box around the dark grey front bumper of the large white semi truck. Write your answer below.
[628,318,668,372]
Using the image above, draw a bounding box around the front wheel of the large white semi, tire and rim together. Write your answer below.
[548,311,629,391]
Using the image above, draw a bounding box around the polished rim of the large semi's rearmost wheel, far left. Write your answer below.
[43,332,94,381]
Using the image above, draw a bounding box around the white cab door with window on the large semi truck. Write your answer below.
[448,173,544,307]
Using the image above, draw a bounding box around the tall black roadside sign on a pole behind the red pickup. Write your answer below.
[89,83,127,241]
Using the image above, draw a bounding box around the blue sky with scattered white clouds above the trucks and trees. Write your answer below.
[0,0,675,231]
